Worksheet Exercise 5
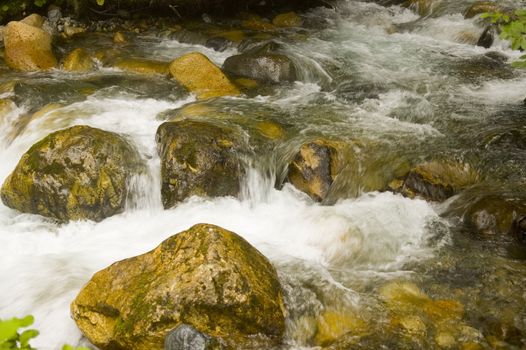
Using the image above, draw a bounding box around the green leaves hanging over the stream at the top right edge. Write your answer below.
[480,9,526,68]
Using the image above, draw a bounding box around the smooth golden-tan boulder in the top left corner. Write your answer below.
[4,22,57,71]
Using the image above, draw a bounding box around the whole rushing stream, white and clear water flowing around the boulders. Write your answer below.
[0,0,526,350]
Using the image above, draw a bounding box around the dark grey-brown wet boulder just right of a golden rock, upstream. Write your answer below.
[223,42,297,83]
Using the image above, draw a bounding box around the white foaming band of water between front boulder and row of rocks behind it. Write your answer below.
[0,186,446,349]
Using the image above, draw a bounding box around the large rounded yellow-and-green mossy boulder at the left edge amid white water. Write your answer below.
[1,125,141,221]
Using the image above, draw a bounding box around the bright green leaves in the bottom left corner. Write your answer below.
[0,315,91,350]
